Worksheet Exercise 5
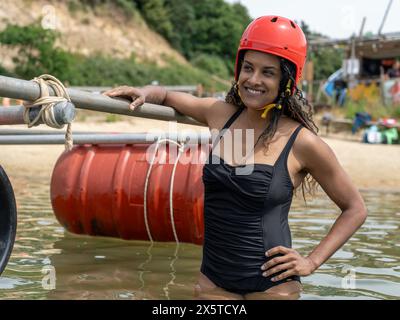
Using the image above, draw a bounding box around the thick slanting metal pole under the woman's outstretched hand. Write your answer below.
[0,76,206,126]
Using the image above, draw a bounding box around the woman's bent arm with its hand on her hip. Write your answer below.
[263,130,367,280]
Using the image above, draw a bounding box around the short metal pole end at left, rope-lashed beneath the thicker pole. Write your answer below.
[0,101,75,125]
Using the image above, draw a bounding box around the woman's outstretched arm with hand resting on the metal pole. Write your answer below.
[103,86,221,125]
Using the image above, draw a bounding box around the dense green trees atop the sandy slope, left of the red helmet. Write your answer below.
[76,0,251,78]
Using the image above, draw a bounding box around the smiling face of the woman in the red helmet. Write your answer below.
[238,50,281,109]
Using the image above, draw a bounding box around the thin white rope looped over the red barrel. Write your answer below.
[143,139,185,243]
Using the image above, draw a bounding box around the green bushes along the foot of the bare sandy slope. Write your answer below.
[0,23,226,90]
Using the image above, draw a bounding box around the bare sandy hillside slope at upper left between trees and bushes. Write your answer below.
[0,0,187,68]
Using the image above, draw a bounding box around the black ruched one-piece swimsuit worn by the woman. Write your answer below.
[201,109,302,294]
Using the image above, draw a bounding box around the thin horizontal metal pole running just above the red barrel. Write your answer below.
[0,132,211,145]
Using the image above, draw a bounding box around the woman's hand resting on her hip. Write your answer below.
[261,246,317,281]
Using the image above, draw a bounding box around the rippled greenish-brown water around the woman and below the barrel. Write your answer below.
[0,172,400,299]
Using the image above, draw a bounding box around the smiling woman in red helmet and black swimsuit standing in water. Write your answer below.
[106,16,367,299]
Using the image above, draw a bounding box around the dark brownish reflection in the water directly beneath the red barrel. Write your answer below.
[42,233,201,299]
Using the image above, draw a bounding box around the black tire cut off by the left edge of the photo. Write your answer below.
[0,166,17,275]
